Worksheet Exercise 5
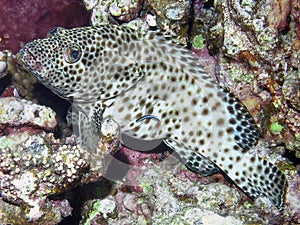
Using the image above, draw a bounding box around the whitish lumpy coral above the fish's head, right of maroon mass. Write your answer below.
[83,0,191,43]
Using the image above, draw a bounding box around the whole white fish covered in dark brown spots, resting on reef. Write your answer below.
[20,25,286,209]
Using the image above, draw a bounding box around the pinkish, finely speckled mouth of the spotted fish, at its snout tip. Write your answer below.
[20,46,44,76]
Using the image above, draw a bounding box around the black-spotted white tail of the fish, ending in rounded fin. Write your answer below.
[222,151,286,210]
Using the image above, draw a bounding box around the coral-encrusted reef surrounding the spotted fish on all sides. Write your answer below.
[0,0,300,225]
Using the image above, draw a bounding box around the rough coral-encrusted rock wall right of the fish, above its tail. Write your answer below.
[199,0,300,158]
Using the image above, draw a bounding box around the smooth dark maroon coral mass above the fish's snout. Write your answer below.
[0,0,89,53]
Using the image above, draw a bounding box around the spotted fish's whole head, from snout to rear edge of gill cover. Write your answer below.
[20,25,145,103]
